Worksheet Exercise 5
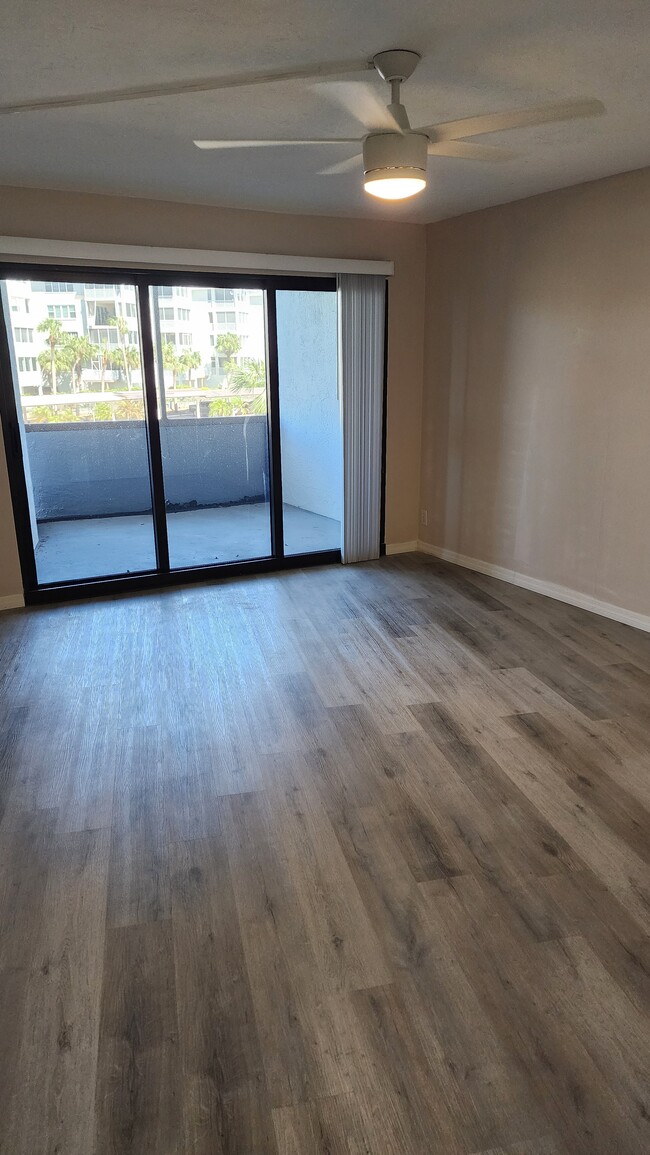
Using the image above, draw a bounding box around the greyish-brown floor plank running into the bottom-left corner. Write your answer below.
[7,830,109,1155]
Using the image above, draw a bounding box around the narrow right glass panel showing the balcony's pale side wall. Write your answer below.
[276,289,343,554]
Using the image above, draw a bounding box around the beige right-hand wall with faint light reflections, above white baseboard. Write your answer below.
[420,170,650,613]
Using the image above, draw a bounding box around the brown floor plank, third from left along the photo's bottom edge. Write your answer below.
[172,830,276,1155]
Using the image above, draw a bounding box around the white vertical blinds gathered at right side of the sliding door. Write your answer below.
[338,273,386,562]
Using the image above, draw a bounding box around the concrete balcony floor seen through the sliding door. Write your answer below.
[36,502,341,583]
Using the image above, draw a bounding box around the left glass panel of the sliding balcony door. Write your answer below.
[1,281,156,583]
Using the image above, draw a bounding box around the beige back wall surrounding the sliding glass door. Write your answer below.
[0,188,425,597]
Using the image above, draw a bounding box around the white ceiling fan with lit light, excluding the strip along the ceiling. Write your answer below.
[194,49,605,200]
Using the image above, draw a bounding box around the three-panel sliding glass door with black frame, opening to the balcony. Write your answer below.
[0,266,342,594]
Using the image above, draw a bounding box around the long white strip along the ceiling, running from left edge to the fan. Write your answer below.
[0,60,374,116]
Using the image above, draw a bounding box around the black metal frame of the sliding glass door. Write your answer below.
[0,261,341,605]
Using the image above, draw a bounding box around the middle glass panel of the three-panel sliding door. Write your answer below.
[151,285,271,569]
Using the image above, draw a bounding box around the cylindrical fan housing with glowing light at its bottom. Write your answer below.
[364,132,428,201]
